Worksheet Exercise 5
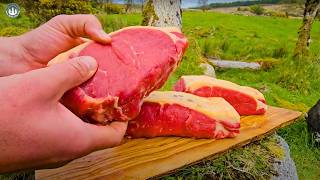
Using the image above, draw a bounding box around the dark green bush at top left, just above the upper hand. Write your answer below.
[19,0,94,24]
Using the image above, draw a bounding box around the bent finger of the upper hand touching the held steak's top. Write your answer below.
[48,14,111,44]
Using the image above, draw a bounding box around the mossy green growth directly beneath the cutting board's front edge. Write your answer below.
[160,136,284,180]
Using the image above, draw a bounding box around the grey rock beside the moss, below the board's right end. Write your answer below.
[270,135,298,180]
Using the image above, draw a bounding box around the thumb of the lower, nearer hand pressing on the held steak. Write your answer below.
[27,56,98,100]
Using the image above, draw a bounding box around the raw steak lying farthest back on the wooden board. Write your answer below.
[174,76,267,115]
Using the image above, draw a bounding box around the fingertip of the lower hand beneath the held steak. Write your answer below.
[86,122,128,151]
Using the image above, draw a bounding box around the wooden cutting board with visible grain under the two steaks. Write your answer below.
[36,107,301,180]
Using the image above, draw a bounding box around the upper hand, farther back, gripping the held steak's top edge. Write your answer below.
[0,15,111,76]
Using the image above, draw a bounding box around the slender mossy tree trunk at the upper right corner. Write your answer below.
[294,0,320,57]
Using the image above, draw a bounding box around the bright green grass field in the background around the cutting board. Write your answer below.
[0,3,320,179]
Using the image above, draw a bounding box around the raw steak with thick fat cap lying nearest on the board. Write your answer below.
[127,91,240,139]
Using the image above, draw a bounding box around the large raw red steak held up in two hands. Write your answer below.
[49,26,188,124]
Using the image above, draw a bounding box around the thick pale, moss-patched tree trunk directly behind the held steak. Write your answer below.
[142,0,182,29]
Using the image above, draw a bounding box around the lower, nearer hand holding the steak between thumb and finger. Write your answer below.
[0,57,127,173]
